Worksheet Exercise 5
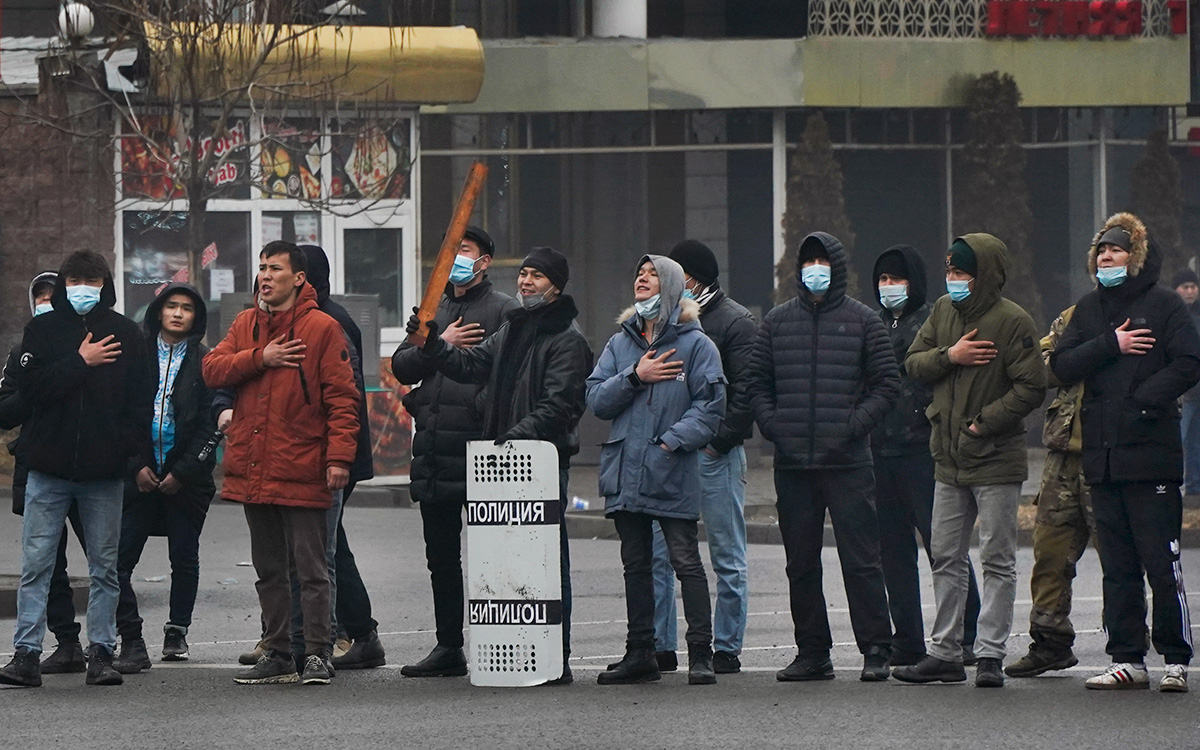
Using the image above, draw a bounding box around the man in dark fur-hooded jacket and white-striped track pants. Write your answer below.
[1050,214,1200,692]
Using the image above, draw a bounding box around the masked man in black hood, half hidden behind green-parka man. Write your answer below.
[871,245,979,666]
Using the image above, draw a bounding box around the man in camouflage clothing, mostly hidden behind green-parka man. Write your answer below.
[1004,306,1096,677]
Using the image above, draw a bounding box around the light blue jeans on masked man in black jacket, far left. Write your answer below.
[13,472,124,653]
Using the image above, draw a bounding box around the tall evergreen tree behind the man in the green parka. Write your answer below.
[954,71,1045,326]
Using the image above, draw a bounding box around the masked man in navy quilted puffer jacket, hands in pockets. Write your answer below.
[750,232,900,682]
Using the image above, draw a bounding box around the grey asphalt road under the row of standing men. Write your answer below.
[0,503,1200,750]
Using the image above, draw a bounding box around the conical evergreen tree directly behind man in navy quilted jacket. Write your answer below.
[775,113,858,302]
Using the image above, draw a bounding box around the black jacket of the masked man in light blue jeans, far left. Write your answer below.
[18,260,155,481]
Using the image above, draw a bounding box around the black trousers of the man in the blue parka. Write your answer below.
[612,510,713,648]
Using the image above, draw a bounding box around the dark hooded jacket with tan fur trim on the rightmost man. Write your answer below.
[1050,214,1200,485]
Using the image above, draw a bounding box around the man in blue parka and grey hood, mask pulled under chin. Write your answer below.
[588,256,725,685]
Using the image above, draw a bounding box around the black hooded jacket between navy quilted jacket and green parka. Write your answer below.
[871,245,934,456]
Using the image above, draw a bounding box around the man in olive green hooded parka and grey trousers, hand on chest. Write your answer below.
[893,234,1046,688]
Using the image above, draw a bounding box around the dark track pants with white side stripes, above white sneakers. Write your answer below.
[1091,482,1192,664]
